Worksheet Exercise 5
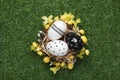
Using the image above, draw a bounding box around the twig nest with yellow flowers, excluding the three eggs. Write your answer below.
[31,12,89,74]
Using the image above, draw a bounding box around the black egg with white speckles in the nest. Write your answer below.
[66,32,83,51]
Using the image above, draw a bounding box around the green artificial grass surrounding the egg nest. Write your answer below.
[0,0,120,80]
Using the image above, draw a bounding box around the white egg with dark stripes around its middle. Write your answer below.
[48,20,67,40]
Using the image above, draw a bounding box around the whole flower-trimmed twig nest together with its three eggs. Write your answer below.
[31,12,89,74]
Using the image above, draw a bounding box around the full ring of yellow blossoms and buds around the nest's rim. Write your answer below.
[31,12,90,74]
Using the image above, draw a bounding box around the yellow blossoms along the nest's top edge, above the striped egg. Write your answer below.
[42,12,81,29]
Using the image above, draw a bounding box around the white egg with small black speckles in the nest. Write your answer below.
[46,40,68,56]
